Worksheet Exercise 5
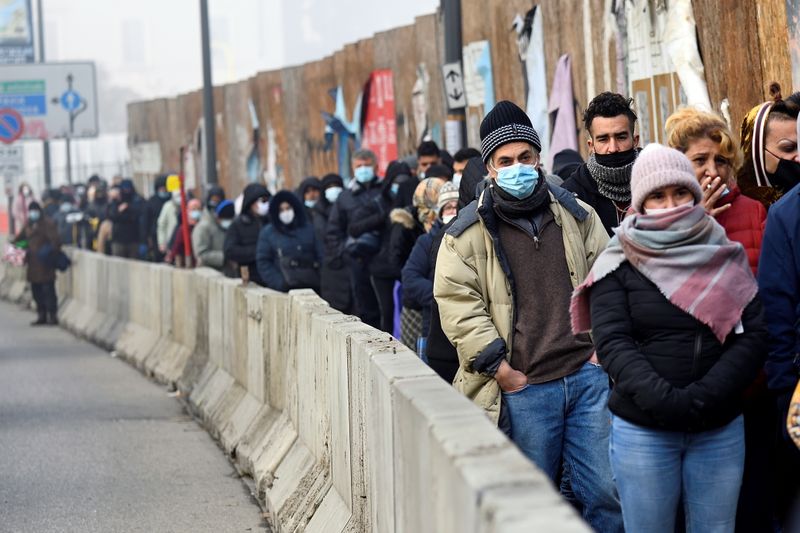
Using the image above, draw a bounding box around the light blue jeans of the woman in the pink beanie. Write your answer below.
[609,416,744,533]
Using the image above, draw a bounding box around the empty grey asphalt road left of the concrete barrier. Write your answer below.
[0,302,266,533]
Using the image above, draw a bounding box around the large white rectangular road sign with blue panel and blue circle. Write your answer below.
[0,63,98,140]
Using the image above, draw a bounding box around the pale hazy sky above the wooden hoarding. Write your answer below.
[39,0,439,102]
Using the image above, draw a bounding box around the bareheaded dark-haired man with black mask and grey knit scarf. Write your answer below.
[562,92,639,235]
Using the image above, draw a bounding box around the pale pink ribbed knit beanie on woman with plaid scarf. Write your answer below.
[631,143,703,213]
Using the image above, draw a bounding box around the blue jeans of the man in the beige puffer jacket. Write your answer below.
[503,363,623,533]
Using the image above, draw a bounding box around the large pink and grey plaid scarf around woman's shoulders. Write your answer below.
[570,205,758,343]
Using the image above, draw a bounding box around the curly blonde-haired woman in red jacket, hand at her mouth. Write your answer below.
[666,108,767,274]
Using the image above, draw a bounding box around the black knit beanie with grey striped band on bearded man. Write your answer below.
[481,100,542,163]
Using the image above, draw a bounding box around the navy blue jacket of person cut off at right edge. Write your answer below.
[758,186,800,393]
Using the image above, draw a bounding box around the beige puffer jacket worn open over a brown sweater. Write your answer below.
[433,187,608,423]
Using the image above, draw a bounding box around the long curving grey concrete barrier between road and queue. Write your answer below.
[0,250,589,533]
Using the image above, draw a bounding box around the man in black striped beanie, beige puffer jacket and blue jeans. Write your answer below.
[434,101,622,532]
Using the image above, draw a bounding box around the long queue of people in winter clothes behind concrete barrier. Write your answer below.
[13,86,800,533]
